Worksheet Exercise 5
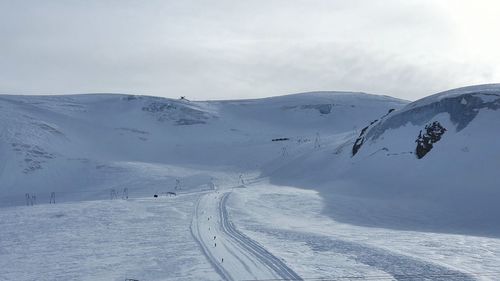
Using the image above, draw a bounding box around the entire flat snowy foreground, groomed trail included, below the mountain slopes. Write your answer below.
[0,178,500,280]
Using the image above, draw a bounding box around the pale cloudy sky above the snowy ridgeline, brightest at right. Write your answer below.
[0,0,500,100]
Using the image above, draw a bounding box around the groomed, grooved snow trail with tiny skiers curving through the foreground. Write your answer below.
[191,188,302,280]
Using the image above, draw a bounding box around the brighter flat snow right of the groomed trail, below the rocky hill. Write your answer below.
[229,182,500,280]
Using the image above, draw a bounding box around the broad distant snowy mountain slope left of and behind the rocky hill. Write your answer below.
[0,92,405,205]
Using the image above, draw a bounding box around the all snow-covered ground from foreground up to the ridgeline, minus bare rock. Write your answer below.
[0,85,500,280]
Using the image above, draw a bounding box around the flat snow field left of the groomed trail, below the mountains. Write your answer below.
[0,195,219,281]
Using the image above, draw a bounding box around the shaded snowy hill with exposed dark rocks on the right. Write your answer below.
[273,84,500,236]
